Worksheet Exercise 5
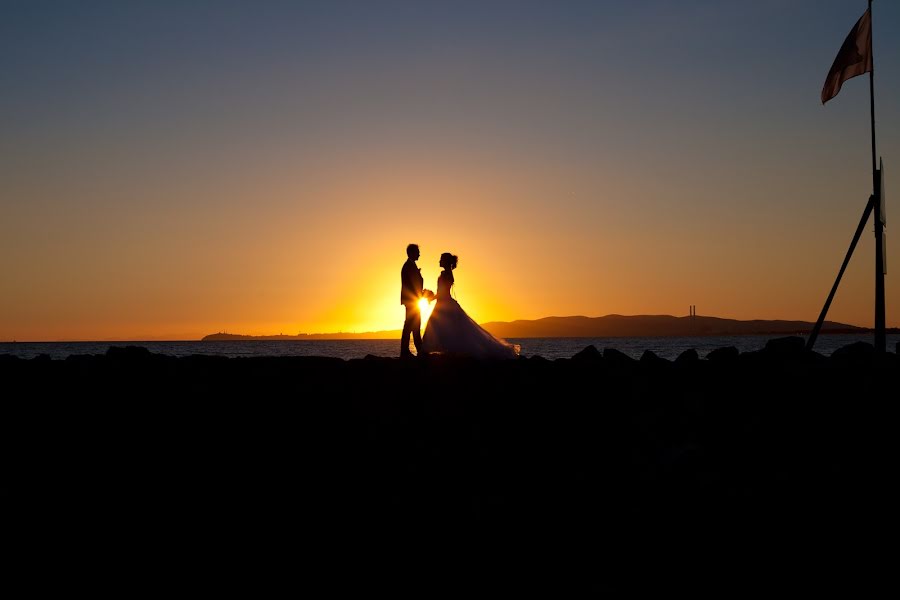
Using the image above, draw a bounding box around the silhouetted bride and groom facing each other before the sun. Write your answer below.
[400,244,519,358]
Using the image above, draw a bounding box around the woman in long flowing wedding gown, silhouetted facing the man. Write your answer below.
[422,252,519,359]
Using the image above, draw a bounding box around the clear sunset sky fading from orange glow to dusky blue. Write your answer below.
[0,0,900,341]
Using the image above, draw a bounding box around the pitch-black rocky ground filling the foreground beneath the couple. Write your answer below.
[0,338,900,596]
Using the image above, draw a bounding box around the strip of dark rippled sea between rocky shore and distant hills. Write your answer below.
[0,333,900,360]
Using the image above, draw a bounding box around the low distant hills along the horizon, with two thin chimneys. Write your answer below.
[202,315,884,342]
